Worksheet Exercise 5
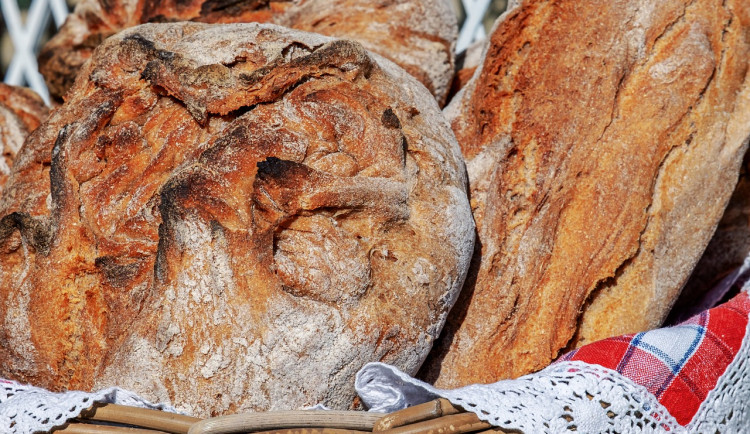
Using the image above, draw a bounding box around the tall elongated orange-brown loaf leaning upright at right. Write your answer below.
[423,0,750,387]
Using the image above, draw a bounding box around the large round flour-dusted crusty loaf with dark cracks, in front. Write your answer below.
[0,23,474,416]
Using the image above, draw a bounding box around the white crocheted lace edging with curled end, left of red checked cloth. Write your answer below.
[355,362,684,433]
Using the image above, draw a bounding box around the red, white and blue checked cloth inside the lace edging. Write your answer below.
[557,292,750,424]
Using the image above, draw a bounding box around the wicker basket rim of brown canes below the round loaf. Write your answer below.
[54,399,506,434]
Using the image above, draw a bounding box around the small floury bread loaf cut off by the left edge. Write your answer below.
[0,83,48,191]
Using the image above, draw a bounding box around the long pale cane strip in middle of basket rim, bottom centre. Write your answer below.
[188,410,382,434]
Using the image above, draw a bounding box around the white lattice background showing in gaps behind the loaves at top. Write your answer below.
[0,0,506,102]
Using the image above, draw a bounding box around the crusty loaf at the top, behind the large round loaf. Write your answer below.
[39,0,458,105]
